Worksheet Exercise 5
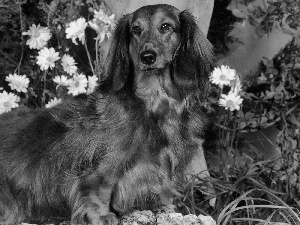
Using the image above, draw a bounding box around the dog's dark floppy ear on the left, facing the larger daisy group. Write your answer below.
[99,15,131,93]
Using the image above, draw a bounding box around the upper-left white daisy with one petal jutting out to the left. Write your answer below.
[22,24,52,49]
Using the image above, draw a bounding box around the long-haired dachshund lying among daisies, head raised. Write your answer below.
[0,4,214,225]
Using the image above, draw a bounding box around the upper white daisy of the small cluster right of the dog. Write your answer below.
[210,65,236,88]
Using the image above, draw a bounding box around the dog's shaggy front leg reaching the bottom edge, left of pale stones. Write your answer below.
[72,171,119,225]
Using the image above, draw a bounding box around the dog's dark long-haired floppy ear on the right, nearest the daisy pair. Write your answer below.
[172,11,214,97]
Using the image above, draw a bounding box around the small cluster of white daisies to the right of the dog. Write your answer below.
[210,65,243,111]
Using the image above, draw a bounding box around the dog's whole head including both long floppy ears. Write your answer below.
[100,4,213,100]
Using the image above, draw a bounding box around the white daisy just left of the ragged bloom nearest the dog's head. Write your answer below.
[66,17,87,45]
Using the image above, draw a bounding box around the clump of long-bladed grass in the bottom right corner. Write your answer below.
[178,157,300,225]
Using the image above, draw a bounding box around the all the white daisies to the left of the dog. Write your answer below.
[0,9,115,114]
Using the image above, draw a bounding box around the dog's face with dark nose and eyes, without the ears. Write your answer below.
[129,5,180,71]
